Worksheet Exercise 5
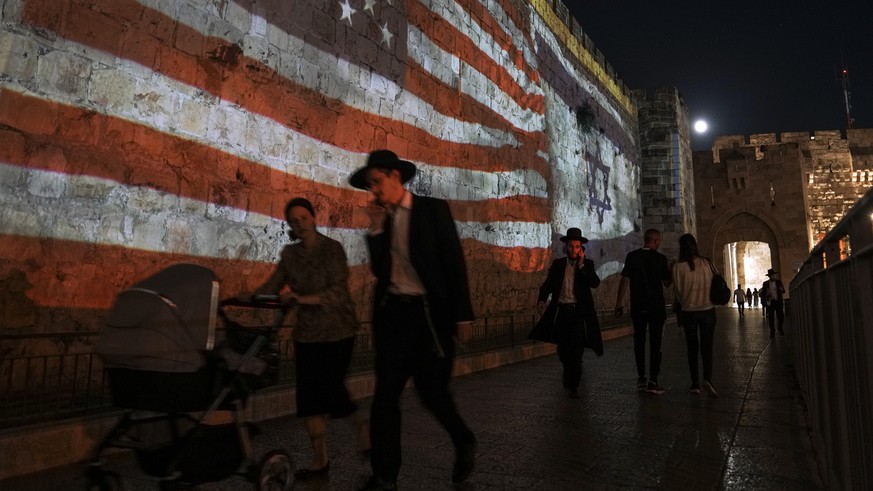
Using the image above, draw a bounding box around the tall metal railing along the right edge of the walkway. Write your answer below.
[789,185,873,489]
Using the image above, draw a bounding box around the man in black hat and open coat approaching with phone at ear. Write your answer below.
[528,228,603,398]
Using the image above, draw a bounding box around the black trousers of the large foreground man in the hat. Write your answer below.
[370,295,476,482]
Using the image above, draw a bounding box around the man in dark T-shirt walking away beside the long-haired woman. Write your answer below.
[614,228,673,395]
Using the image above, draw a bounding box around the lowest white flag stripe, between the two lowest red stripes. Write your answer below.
[0,163,551,265]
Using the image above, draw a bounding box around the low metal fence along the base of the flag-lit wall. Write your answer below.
[0,311,628,428]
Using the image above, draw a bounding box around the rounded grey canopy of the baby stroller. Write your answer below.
[95,264,218,372]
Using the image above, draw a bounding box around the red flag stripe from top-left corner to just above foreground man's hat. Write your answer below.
[22,0,548,177]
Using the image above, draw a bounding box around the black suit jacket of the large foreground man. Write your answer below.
[367,194,473,334]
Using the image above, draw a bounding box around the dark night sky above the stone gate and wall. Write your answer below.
[563,0,873,150]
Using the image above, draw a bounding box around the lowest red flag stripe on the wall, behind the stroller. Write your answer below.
[0,234,549,309]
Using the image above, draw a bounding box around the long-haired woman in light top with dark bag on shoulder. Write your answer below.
[673,234,718,397]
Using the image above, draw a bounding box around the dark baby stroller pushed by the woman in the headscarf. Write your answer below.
[88,264,293,490]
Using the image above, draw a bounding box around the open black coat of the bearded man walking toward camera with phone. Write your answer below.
[528,257,603,356]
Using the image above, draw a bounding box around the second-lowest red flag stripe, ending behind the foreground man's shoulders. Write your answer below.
[0,89,550,228]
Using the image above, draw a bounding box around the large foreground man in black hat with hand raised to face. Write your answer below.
[349,150,476,490]
